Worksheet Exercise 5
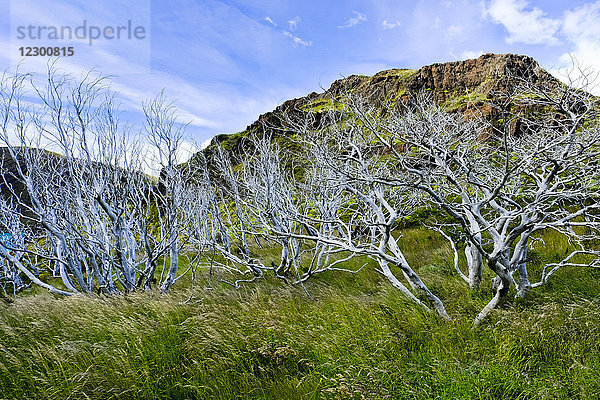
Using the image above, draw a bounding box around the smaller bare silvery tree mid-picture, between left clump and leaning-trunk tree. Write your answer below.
[206,137,302,286]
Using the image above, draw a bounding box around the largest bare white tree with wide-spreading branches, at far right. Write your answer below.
[328,71,600,323]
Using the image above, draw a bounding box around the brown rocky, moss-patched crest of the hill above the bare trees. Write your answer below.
[205,54,557,159]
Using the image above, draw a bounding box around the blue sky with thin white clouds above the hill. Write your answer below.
[0,0,600,151]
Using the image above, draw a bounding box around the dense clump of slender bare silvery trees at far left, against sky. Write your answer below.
[0,65,195,293]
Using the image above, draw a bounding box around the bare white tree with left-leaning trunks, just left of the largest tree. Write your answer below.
[270,111,449,318]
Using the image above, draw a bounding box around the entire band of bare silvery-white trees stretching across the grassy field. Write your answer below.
[0,63,600,323]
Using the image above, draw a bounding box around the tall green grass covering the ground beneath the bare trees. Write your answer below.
[0,229,600,399]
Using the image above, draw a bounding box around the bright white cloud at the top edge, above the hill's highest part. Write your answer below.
[486,0,560,45]
